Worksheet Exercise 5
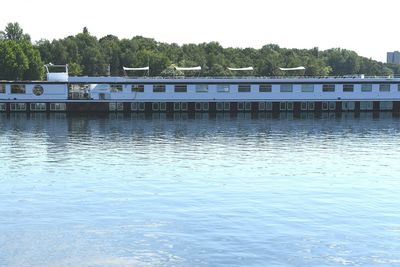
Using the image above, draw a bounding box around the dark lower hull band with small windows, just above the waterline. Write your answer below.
[0,101,400,114]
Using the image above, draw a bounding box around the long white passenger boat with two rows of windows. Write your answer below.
[0,66,400,114]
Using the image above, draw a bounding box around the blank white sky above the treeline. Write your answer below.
[0,0,400,62]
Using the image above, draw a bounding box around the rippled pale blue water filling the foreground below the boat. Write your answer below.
[0,113,400,267]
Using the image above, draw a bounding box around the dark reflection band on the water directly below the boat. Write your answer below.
[0,112,399,149]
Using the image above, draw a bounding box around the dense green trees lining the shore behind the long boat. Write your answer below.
[0,22,400,80]
